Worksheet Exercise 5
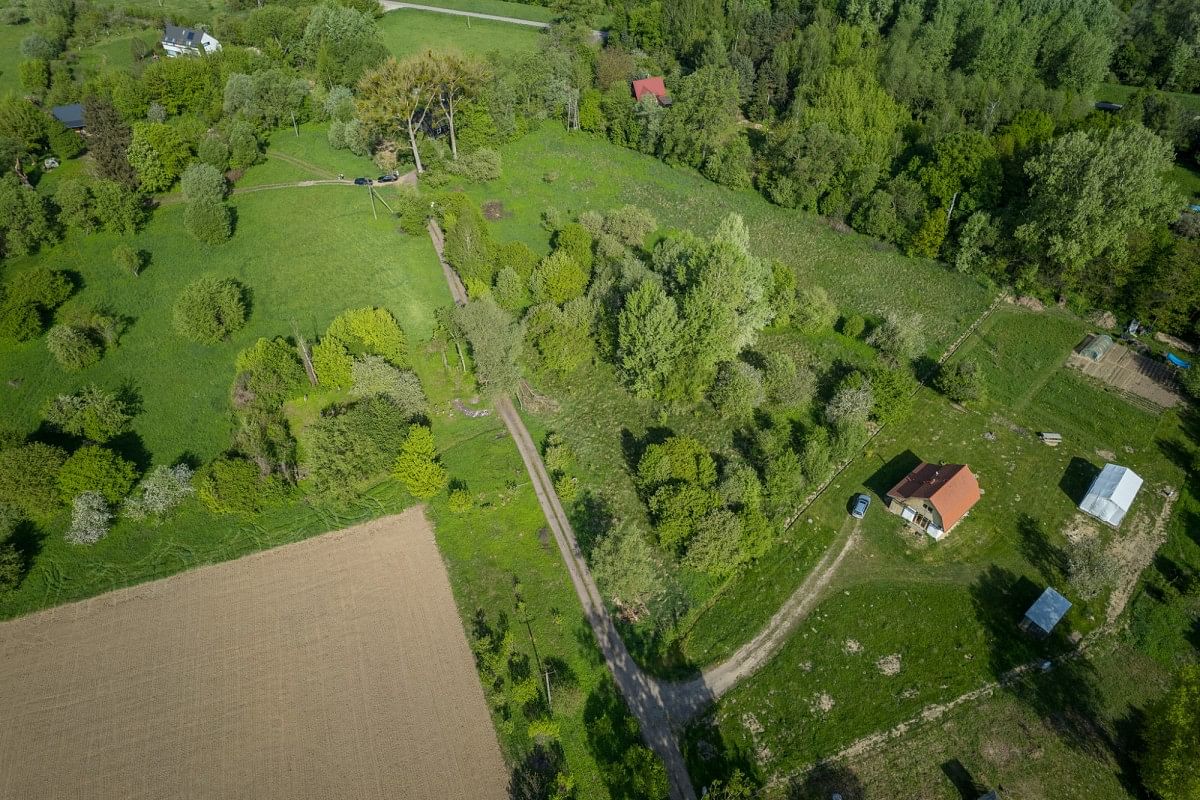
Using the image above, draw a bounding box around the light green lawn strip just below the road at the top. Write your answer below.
[378,8,541,58]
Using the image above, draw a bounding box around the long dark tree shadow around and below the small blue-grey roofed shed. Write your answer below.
[971,565,1116,756]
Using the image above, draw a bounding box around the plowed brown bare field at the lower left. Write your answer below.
[0,509,506,800]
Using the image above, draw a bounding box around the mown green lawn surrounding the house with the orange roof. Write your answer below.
[685,307,1189,796]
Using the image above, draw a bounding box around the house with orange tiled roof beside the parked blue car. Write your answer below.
[888,462,979,541]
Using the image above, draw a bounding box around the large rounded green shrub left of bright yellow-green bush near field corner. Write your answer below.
[305,397,408,497]
